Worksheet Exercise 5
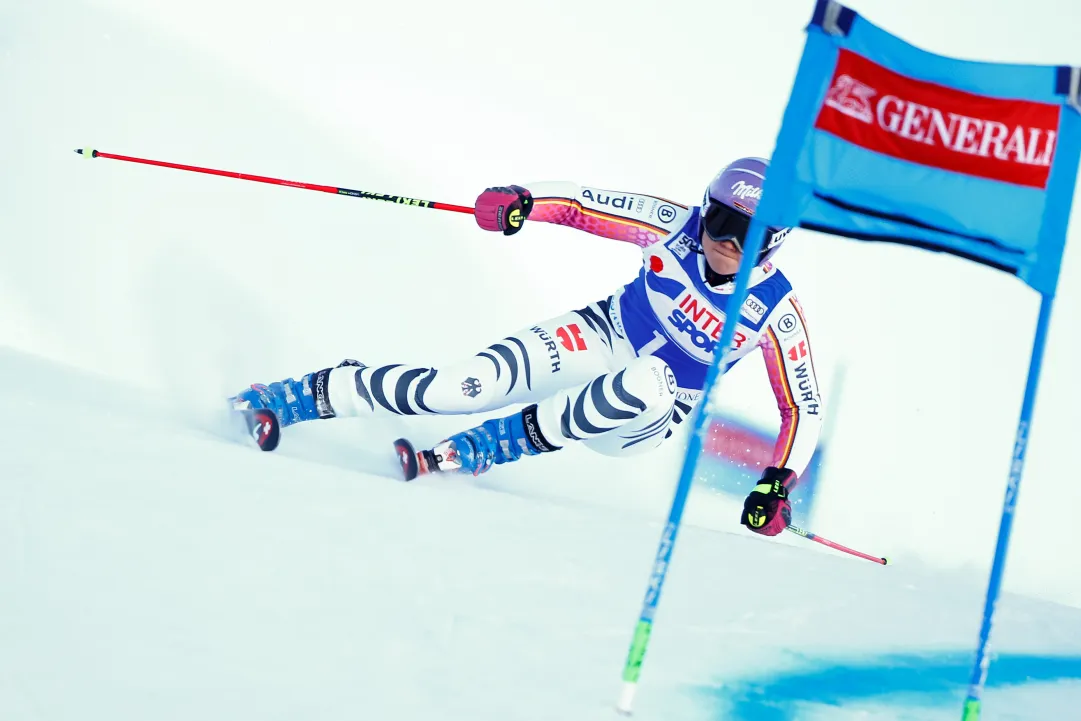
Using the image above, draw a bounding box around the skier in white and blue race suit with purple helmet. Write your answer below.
[231,158,823,535]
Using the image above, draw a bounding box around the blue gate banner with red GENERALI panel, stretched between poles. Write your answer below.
[758,0,1081,295]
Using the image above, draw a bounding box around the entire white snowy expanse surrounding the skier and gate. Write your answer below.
[0,0,1081,721]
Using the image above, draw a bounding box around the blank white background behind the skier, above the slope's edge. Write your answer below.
[0,0,1081,604]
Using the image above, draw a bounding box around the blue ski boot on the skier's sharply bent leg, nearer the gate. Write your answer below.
[395,405,561,481]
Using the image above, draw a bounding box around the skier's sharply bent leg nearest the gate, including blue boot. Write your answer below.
[417,356,676,476]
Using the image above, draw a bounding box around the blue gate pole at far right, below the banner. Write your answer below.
[961,294,1055,721]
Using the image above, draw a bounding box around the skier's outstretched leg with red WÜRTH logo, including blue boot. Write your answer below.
[237,301,633,426]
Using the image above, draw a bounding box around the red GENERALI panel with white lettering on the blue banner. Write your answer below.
[814,50,1060,189]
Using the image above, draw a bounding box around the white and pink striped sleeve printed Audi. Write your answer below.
[525,182,692,248]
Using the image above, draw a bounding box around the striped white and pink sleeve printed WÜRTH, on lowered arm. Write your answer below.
[759,293,823,476]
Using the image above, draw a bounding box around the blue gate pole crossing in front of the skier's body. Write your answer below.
[616,216,765,716]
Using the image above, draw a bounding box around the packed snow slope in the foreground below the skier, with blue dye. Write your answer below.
[0,341,1081,721]
